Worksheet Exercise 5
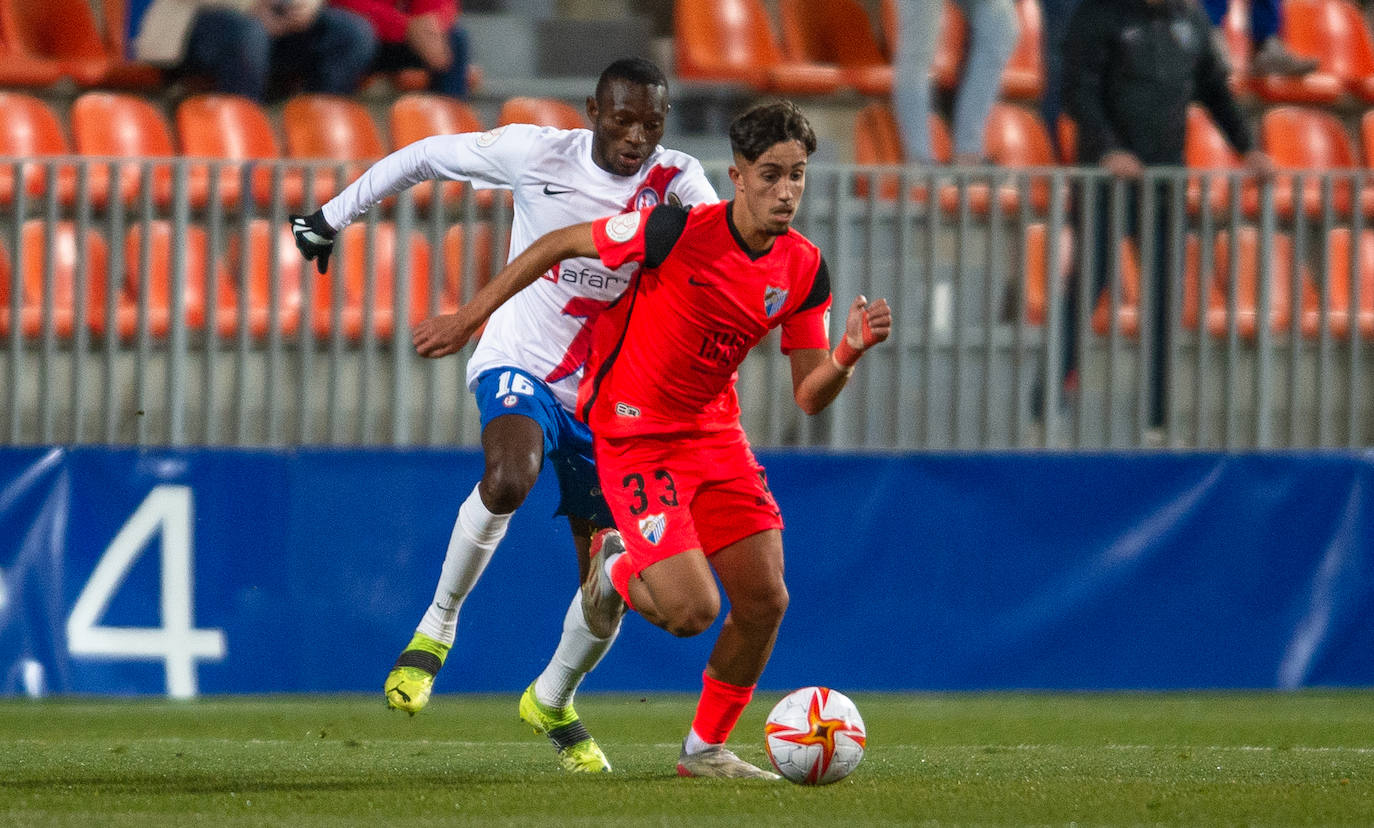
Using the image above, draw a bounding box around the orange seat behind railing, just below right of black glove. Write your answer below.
[313,221,434,339]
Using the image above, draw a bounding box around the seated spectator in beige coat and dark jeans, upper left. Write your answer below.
[133,0,376,102]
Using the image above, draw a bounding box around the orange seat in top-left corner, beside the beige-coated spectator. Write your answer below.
[0,0,162,91]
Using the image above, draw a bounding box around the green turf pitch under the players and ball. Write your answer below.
[0,692,1374,828]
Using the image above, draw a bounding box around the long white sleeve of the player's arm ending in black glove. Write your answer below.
[323,124,543,231]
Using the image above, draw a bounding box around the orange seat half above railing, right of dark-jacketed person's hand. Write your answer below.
[1260,106,1359,217]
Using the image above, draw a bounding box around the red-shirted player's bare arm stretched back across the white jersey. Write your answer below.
[411,224,596,358]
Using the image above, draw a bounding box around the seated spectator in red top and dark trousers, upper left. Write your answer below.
[330,0,467,97]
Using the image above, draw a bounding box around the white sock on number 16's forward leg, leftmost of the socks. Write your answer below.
[415,486,514,644]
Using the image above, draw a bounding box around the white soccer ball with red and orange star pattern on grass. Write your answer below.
[764,687,868,785]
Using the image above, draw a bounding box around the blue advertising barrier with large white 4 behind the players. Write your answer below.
[0,448,1374,698]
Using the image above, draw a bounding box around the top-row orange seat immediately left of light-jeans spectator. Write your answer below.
[778,0,892,97]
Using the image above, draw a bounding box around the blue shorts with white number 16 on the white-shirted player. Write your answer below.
[473,368,614,526]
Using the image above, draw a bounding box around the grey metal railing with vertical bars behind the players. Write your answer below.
[0,158,1374,450]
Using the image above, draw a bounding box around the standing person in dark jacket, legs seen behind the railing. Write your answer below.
[1063,0,1274,427]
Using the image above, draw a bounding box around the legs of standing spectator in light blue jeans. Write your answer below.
[892,0,1021,163]
